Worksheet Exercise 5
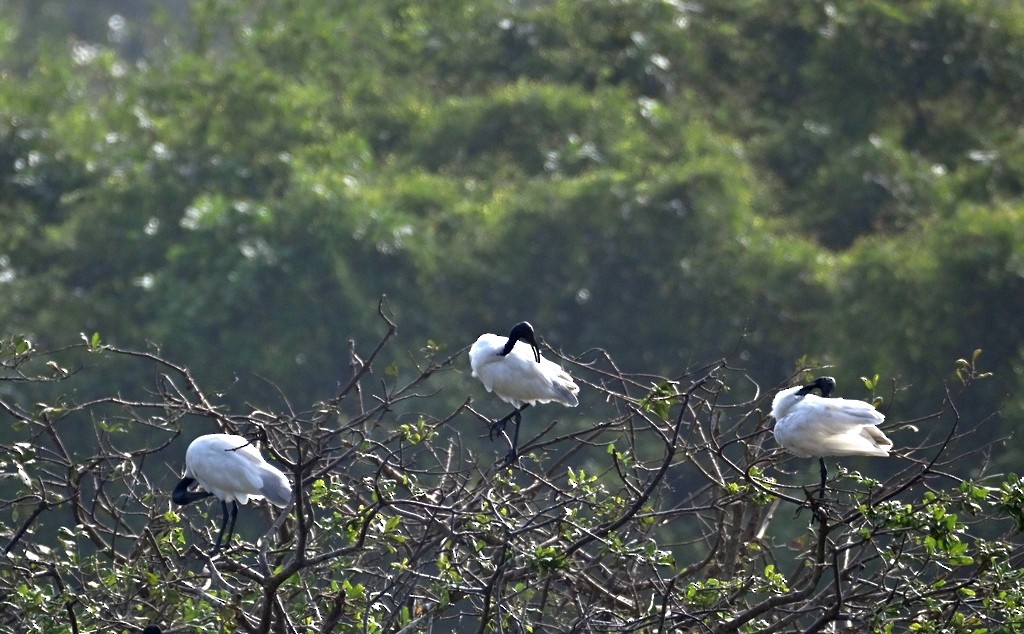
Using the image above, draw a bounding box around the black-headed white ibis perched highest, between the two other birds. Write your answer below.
[469,322,580,464]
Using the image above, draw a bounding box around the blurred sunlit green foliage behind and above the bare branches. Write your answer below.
[0,0,1024,465]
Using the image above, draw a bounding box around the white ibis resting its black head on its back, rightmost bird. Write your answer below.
[771,377,893,497]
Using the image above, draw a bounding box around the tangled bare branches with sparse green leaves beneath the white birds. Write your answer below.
[0,317,1024,632]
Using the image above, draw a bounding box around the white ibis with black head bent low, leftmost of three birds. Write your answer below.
[171,433,292,554]
